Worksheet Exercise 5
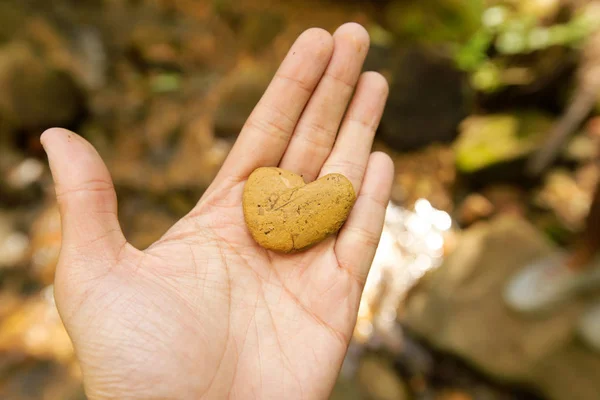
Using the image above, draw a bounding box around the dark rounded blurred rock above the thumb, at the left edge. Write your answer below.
[0,42,83,133]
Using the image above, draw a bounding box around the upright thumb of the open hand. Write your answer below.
[40,128,127,259]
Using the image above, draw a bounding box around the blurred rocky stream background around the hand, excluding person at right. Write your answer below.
[0,0,600,400]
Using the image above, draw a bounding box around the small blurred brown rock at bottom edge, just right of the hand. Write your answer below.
[357,356,409,400]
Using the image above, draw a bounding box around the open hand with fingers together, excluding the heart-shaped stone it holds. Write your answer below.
[41,24,393,400]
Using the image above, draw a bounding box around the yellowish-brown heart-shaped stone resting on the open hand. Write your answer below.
[242,167,356,253]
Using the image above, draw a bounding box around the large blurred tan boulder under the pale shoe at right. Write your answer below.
[406,217,600,400]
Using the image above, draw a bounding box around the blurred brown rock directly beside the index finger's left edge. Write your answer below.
[214,62,271,137]
